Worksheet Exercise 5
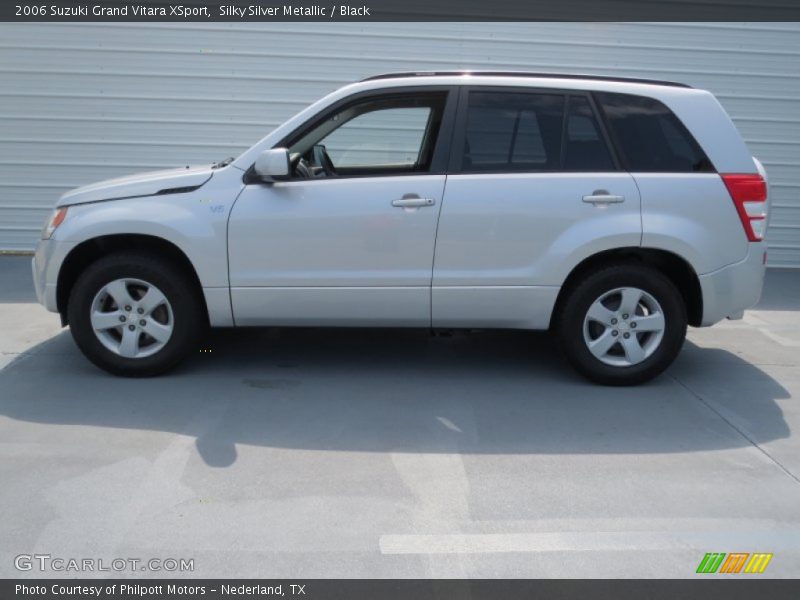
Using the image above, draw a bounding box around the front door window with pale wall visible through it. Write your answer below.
[289,93,446,178]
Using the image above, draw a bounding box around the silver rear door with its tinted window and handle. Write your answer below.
[432,88,641,328]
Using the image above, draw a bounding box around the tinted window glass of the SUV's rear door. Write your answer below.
[461,91,616,172]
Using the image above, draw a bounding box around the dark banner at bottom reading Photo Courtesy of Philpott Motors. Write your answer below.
[0,576,800,600]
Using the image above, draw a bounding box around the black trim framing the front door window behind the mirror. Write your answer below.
[270,85,458,182]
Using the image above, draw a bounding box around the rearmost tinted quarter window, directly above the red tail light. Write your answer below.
[595,92,714,173]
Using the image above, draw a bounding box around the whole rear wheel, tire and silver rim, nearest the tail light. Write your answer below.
[556,264,687,385]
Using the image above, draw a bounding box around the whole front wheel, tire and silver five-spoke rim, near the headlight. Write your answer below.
[67,253,205,377]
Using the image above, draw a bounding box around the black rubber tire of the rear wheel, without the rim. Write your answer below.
[554,263,687,385]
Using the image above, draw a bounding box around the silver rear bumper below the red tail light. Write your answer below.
[699,242,767,327]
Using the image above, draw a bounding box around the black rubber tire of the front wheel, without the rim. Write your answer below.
[67,252,207,377]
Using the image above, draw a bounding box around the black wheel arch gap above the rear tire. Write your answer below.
[550,247,703,327]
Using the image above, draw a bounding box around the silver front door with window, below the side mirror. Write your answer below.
[228,90,449,326]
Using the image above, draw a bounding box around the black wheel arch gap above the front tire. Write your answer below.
[56,233,208,325]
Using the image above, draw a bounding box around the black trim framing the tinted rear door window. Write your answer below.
[447,85,625,175]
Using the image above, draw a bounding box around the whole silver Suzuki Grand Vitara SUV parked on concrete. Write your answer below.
[33,72,768,384]
